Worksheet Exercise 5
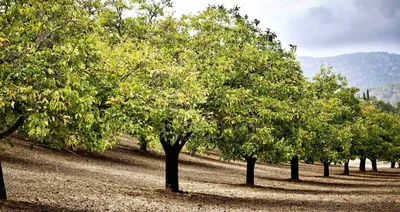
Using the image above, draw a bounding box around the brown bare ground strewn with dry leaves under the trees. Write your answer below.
[0,136,400,211]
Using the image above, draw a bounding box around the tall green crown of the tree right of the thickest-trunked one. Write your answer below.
[183,6,303,162]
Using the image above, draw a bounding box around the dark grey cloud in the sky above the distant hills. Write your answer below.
[283,0,400,48]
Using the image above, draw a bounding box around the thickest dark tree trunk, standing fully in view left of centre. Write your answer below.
[164,147,180,192]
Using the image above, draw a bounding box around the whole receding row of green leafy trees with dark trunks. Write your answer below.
[0,0,400,198]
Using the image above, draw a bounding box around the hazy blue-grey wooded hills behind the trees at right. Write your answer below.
[297,52,400,104]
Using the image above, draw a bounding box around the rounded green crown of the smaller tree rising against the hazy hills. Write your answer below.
[303,67,361,162]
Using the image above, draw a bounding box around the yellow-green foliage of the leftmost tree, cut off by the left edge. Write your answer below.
[0,0,124,151]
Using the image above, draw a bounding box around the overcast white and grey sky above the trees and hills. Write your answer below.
[173,0,400,57]
